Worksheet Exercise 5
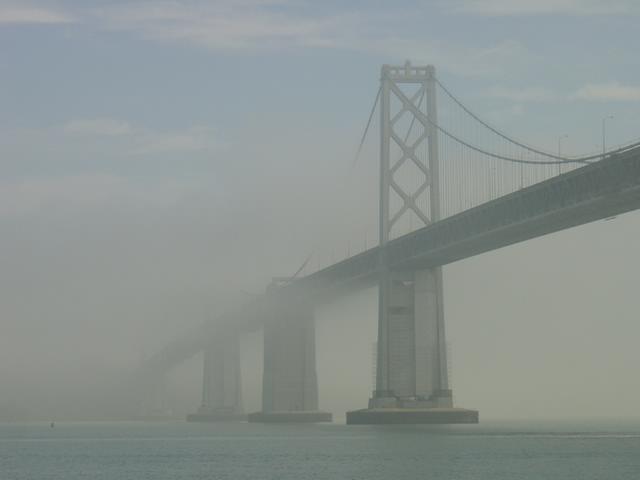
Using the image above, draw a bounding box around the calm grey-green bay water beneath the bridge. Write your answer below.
[0,420,640,480]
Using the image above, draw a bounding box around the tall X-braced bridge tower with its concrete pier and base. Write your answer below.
[347,62,478,424]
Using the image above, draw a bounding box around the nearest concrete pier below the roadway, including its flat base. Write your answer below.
[347,268,478,424]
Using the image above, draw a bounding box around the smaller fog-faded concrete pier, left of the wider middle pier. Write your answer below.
[187,328,246,422]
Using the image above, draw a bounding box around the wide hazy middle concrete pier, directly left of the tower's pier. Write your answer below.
[249,300,332,422]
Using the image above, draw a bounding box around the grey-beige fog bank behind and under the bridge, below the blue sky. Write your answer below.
[5,117,640,419]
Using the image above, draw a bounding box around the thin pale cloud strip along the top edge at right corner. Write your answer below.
[442,0,640,16]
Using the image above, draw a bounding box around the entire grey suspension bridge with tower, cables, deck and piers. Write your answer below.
[140,62,640,424]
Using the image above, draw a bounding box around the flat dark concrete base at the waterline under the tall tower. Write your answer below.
[347,408,478,425]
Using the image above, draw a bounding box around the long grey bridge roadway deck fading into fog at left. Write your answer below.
[145,147,640,374]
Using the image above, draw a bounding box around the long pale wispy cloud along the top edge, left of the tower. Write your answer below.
[96,0,358,50]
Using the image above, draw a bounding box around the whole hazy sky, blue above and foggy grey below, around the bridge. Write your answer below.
[0,0,640,417]
